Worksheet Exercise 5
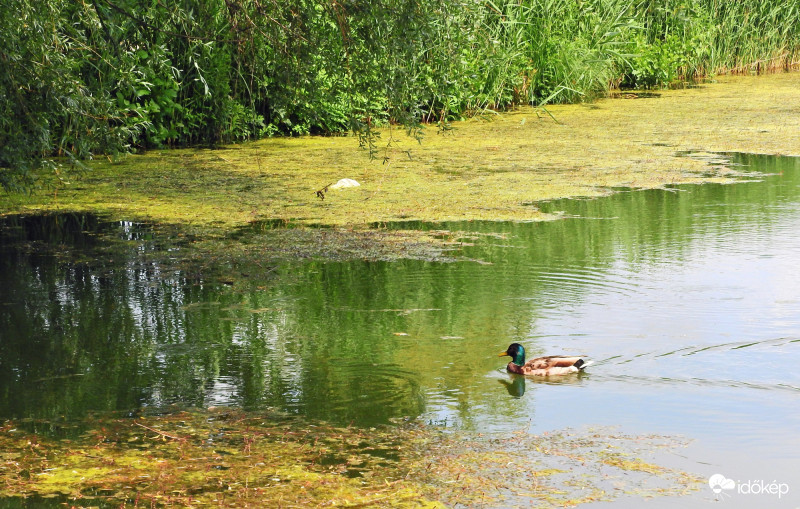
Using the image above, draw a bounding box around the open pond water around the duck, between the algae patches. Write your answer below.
[0,154,800,508]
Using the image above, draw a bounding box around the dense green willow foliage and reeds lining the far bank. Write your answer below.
[0,0,800,189]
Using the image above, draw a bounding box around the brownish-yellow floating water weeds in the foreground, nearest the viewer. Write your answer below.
[0,409,698,508]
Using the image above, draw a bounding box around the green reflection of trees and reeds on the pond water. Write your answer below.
[0,156,800,423]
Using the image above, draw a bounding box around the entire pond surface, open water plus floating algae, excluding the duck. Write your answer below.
[0,74,800,507]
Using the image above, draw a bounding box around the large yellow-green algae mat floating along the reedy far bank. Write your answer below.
[0,73,800,228]
